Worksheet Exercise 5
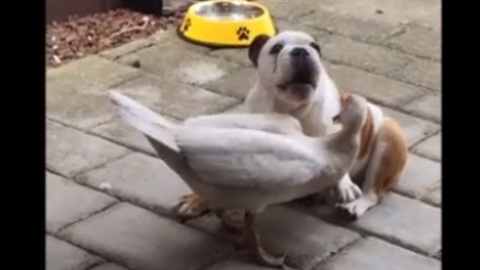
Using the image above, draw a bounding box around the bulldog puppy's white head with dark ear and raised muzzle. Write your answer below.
[249,31,323,105]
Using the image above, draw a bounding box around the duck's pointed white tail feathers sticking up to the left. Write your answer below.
[108,90,180,153]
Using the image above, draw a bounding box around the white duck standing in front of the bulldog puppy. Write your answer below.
[109,91,367,267]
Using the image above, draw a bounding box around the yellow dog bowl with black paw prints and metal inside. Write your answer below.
[178,0,277,47]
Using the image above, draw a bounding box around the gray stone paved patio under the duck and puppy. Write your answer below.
[45,0,442,270]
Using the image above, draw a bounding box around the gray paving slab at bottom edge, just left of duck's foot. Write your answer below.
[62,203,231,270]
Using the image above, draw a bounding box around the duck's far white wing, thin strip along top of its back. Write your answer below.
[184,113,302,135]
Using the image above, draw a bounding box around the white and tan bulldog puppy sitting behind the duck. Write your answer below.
[176,31,407,218]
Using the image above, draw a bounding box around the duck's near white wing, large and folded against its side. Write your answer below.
[177,127,324,189]
